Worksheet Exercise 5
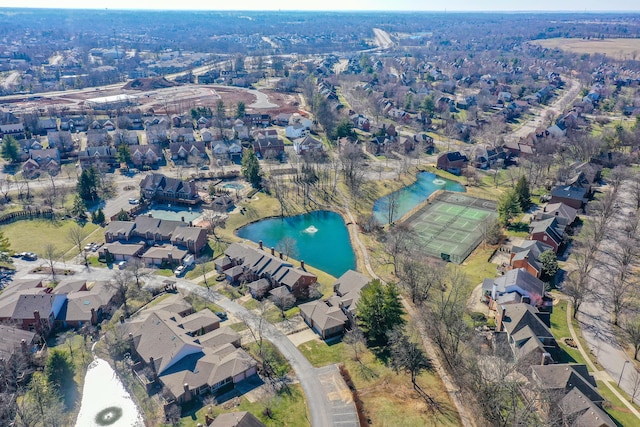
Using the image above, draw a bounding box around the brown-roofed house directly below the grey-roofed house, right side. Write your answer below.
[496,304,558,365]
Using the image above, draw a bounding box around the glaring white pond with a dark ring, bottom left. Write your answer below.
[76,358,144,427]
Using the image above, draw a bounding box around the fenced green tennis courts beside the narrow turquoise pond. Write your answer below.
[406,192,497,264]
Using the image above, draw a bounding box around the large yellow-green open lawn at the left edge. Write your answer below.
[0,219,104,258]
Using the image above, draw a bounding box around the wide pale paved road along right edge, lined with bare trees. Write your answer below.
[578,182,640,397]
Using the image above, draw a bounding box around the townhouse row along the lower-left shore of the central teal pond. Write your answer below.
[222,243,317,298]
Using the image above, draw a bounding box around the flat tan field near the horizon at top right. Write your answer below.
[531,38,640,59]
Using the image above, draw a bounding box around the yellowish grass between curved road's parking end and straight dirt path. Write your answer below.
[299,341,460,427]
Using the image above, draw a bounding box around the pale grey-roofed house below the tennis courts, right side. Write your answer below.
[482,268,553,311]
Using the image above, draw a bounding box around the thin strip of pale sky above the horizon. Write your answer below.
[0,0,640,12]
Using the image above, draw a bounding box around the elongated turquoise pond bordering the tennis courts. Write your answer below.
[373,172,465,224]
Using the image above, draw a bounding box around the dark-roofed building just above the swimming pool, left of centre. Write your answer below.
[140,173,201,205]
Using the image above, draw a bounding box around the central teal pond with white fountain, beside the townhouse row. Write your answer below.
[237,211,356,277]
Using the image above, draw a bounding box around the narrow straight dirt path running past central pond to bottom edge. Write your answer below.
[338,190,475,427]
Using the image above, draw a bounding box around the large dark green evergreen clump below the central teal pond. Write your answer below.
[356,279,405,344]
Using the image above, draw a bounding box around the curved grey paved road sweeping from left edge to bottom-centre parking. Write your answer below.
[10,260,352,427]
